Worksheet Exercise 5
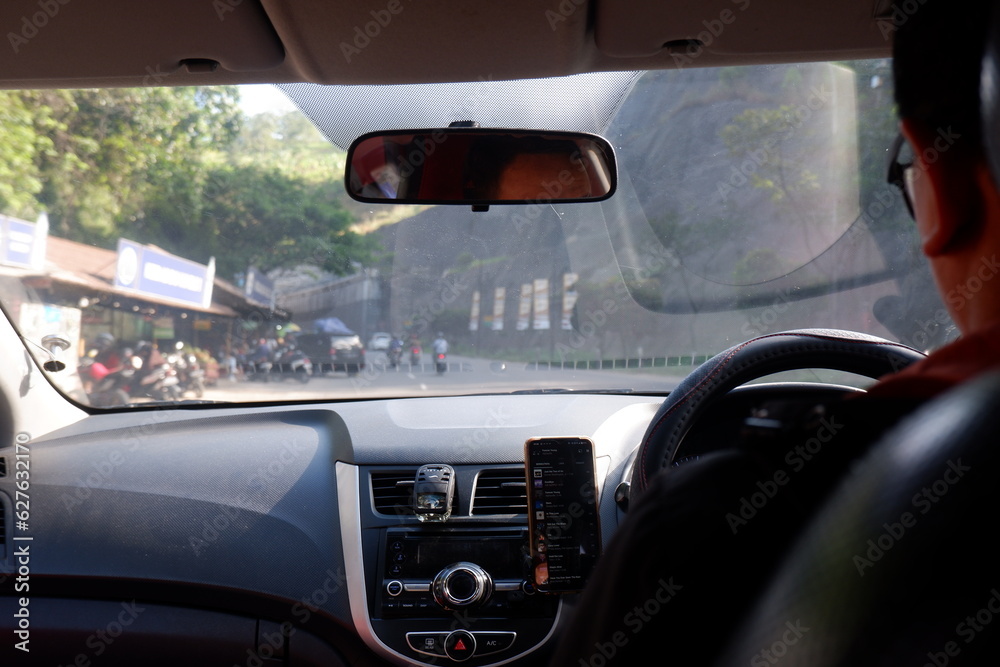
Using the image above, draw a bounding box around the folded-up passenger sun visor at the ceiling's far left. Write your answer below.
[0,0,285,85]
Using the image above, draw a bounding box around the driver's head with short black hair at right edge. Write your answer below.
[893,0,1000,333]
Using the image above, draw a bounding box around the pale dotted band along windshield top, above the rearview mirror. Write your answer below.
[278,72,639,149]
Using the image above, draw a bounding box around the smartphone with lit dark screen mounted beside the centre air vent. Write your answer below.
[524,437,601,593]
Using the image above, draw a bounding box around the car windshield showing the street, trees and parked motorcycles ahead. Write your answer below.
[0,60,955,407]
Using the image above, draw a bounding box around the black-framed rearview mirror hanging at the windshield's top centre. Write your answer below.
[346,128,618,207]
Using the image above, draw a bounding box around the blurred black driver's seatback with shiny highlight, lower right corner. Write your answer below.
[716,374,1000,667]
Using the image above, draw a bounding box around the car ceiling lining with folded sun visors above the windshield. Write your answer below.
[0,0,892,88]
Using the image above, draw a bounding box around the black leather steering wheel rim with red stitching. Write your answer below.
[631,329,924,494]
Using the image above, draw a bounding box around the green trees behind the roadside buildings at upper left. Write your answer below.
[0,87,376,278]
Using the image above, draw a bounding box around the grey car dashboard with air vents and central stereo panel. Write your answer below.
[0,394,659,665]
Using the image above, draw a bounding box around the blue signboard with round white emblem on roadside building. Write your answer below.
[115,239,215,308]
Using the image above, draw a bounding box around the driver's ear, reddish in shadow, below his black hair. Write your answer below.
[901,119,983,258]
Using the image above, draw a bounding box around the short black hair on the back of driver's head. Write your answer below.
[891,0,997,147]
